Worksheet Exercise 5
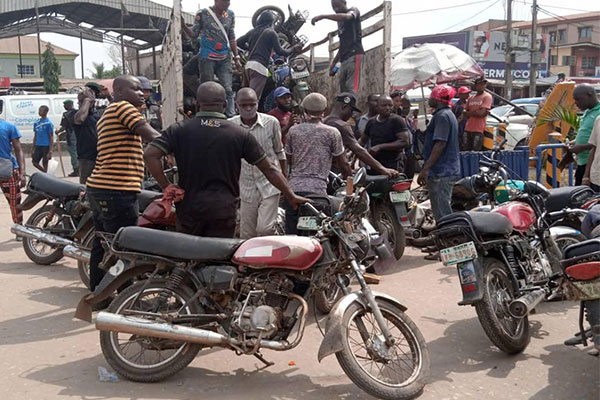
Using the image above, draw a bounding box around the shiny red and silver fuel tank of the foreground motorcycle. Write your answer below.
[233,236,323,271]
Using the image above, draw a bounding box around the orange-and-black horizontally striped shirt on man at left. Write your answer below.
[87,101,144,192]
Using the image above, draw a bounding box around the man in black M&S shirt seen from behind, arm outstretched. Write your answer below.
[144,82,306,238]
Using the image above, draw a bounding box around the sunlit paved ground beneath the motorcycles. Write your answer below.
[0,195,600,400]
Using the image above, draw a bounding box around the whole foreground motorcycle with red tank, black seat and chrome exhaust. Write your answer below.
[76,170,430,399]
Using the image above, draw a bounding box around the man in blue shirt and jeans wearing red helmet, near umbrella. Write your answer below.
[418,85,460,221]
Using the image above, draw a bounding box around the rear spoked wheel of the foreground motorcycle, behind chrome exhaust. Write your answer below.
[100,279,202,382]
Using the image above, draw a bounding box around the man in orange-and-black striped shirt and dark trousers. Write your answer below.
[84,75,159,292]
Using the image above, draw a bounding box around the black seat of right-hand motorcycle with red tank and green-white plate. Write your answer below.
[438,211,513,236]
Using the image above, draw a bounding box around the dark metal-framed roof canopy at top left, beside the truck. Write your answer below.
[0,0,194,50]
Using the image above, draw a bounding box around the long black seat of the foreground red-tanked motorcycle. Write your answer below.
[115,226,244,262]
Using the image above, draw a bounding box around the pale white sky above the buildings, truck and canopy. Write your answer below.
[30,0,593,78]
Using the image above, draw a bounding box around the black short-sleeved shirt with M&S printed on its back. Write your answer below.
[151,112,266,220]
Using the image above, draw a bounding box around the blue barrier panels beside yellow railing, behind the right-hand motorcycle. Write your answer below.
[460,147,529,181]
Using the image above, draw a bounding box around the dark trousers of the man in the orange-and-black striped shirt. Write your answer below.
[87,187,139,292]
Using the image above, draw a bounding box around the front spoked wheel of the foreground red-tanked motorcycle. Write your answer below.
[335,300,430,400]
